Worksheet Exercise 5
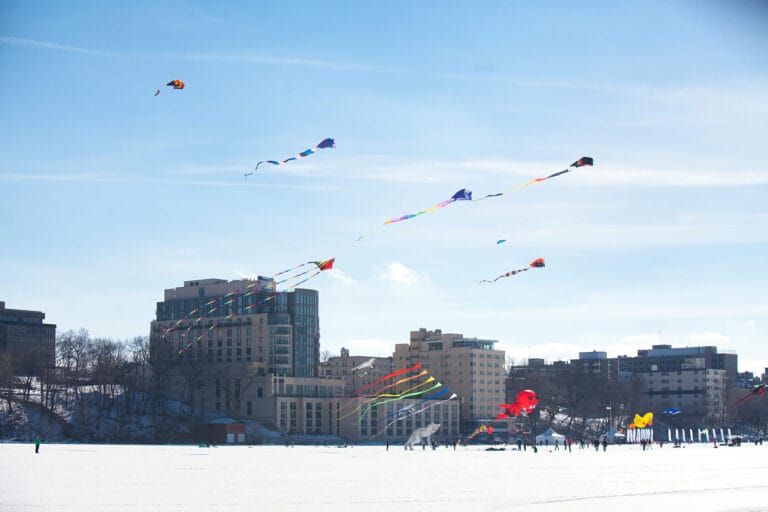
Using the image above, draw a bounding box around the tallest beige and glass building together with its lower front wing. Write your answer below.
[150,277,344,434]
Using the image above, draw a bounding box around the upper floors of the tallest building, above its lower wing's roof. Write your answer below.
[150,277,320,377]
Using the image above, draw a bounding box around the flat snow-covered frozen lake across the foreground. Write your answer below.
[0,443,768,512]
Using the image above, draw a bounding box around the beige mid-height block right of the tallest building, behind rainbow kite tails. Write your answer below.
[394,328,505,430]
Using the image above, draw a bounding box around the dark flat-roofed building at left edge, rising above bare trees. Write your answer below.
[0,301,56,367]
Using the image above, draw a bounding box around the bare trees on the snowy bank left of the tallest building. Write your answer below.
[0,329,191,442]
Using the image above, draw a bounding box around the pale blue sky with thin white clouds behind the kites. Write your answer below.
[0,0,768,374]
